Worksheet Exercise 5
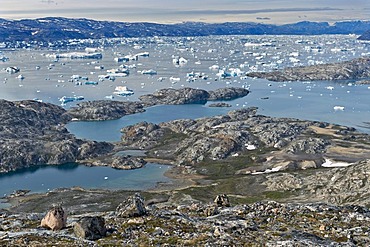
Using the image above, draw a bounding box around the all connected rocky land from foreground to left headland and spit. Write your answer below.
[0,88,370,246]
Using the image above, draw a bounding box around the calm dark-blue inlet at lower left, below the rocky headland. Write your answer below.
[0,163,169,198]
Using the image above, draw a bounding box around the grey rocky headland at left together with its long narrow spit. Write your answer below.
[0,88,249,173]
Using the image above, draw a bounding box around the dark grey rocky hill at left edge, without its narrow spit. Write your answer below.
[0,100,113,172]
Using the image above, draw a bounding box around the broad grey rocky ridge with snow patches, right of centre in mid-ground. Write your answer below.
[122,108,370,173]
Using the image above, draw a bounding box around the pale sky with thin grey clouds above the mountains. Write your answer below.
[0,0,370,24]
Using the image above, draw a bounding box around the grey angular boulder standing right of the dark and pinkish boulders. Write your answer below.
[116,193,147,218]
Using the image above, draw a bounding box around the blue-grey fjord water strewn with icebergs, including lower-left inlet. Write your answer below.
[0,35,370,193]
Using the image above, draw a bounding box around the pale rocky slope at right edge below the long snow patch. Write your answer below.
[264,160,370,205]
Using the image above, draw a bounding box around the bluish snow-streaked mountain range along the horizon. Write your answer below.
[0,17,370,45]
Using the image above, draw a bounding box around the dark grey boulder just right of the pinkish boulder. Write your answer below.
[73,216,107,240]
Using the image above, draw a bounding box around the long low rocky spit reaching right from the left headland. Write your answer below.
[67,87,249,121]
